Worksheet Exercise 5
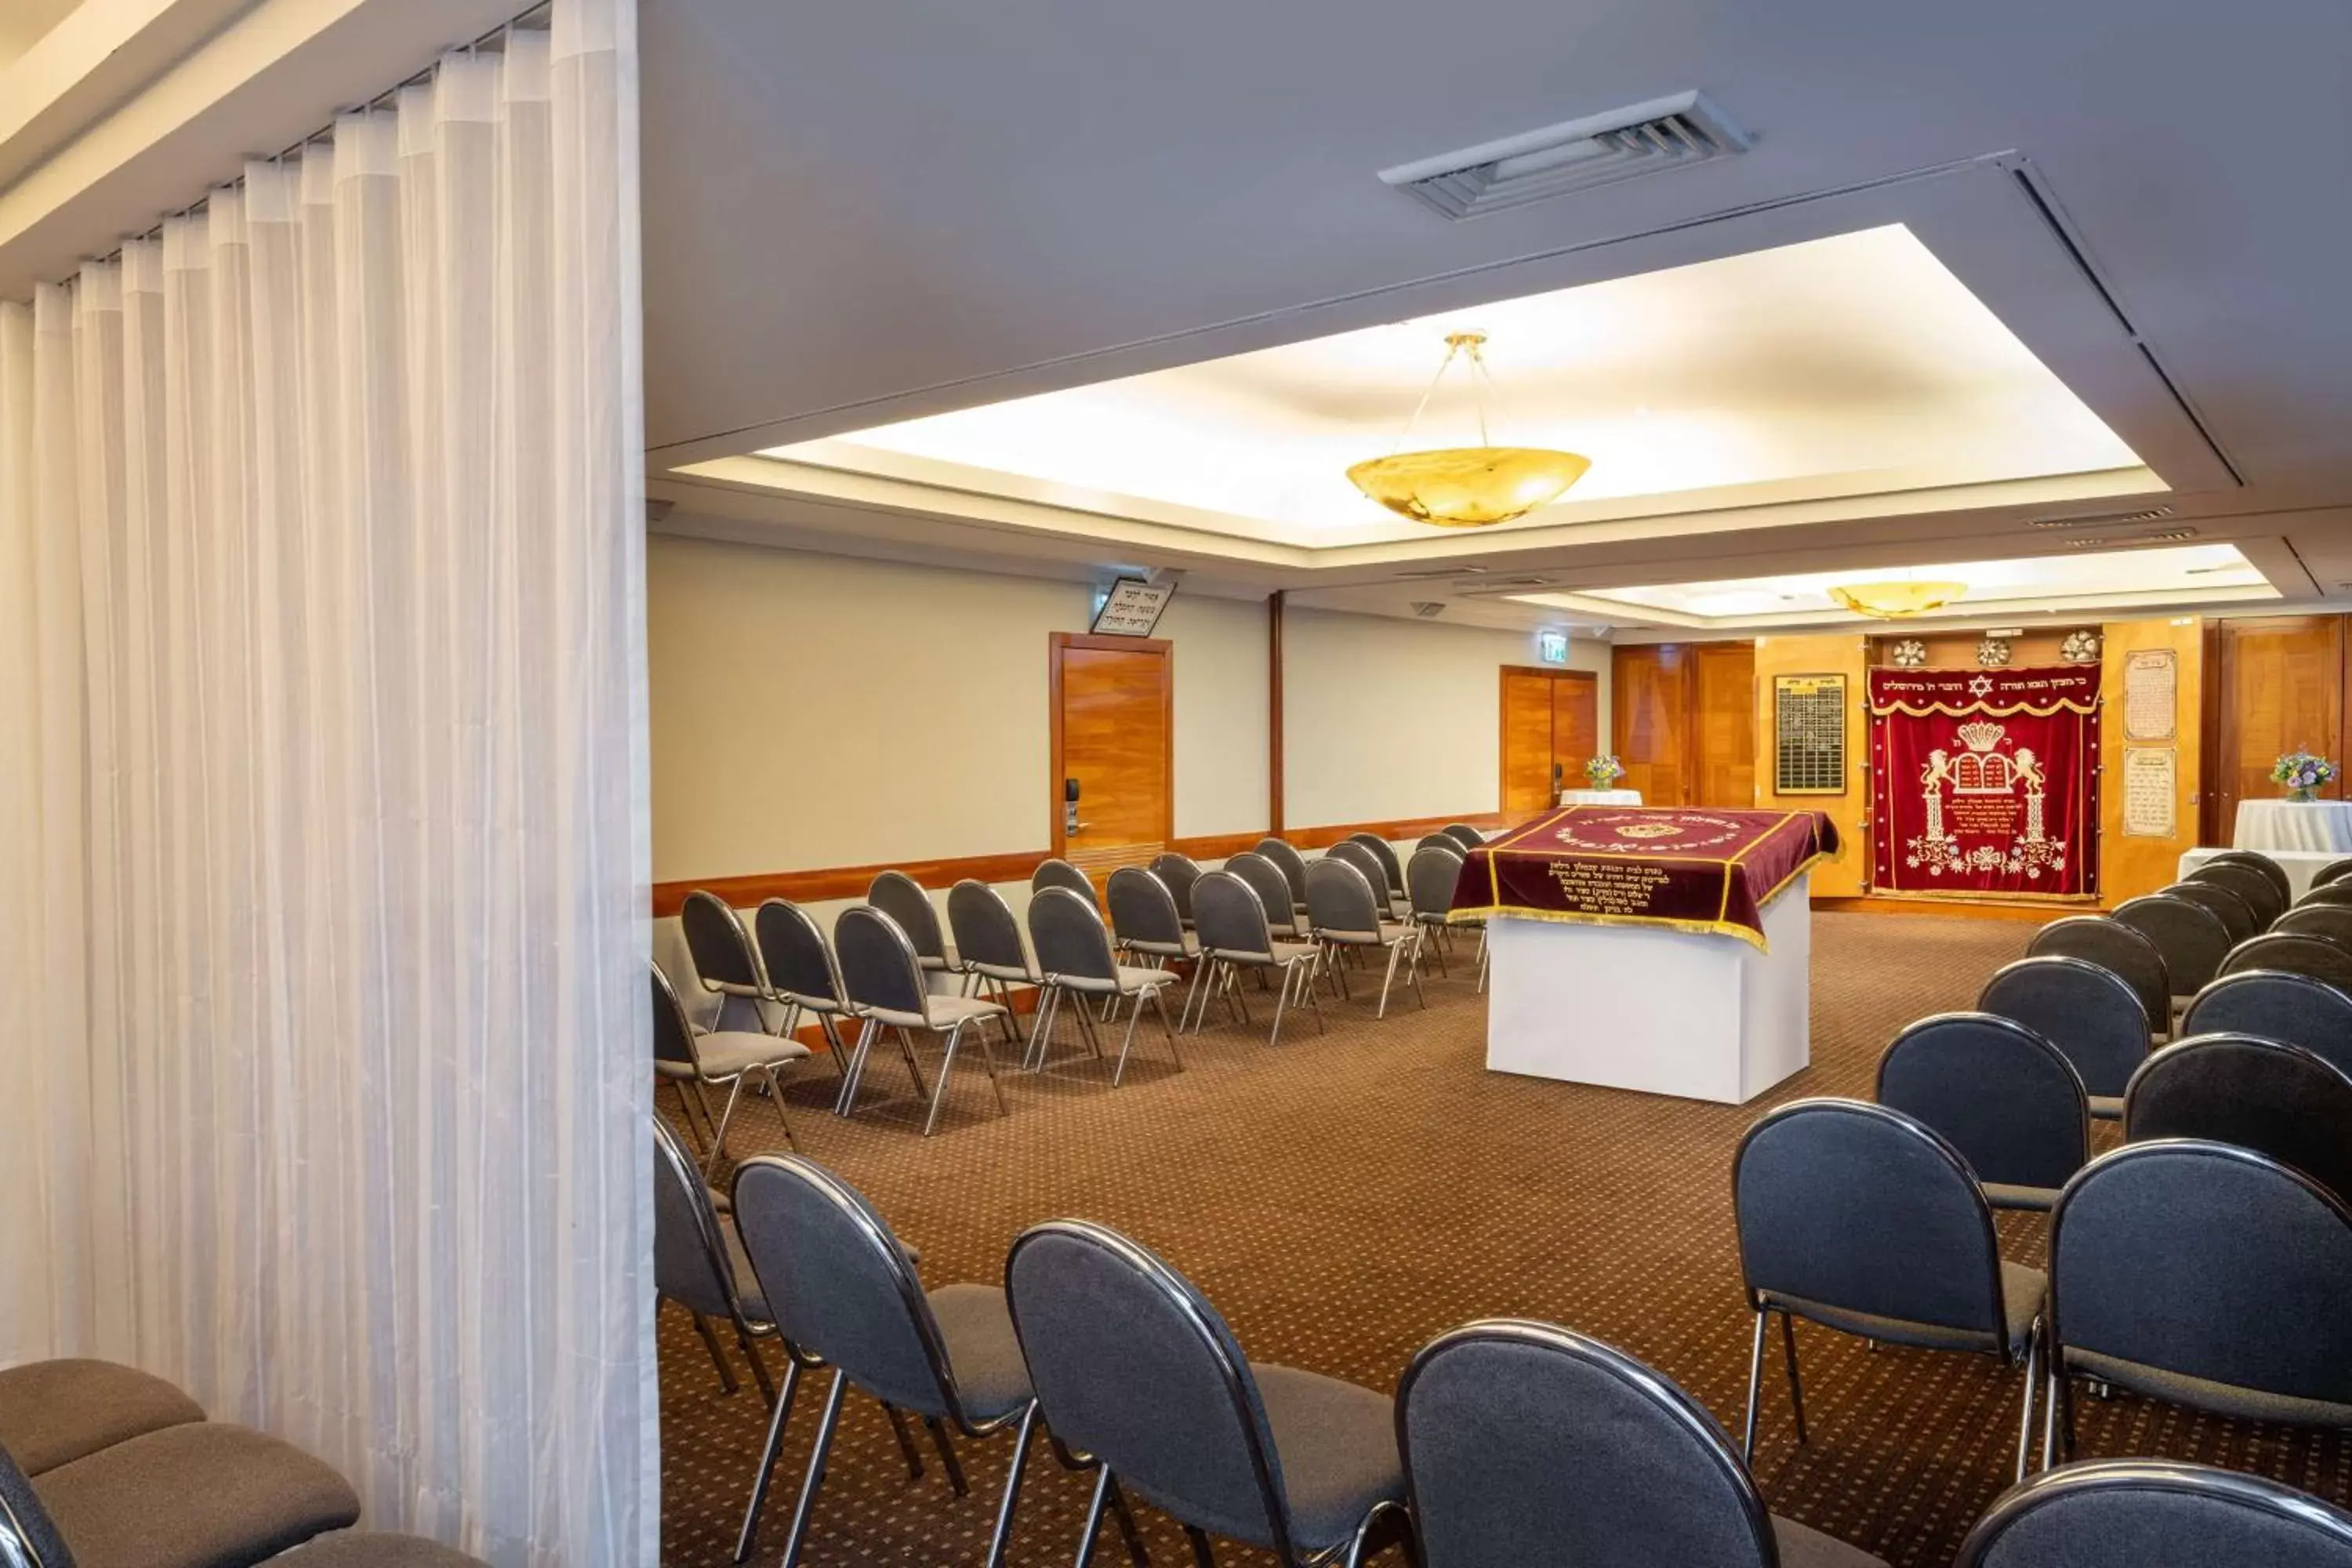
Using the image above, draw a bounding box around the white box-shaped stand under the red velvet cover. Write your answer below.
[1486,874,1813,1105]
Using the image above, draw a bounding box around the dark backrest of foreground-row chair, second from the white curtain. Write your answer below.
[734,1154,962,1417]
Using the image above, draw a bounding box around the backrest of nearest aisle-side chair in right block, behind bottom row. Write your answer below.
[1731,1100,2006,1349]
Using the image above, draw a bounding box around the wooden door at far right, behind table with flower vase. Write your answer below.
[2211,616,2345,844]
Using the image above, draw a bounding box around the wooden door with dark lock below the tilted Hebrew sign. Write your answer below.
[1049,633,1176,881]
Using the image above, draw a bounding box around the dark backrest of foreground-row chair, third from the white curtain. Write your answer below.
[1004,1220,1294,1563]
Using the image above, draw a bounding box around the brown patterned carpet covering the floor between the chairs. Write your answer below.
[661,914,2352,1568]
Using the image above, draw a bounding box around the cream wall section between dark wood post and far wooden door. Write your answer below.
[1282,609,1609,827]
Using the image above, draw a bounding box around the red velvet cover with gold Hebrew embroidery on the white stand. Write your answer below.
[1454,806,1837,947]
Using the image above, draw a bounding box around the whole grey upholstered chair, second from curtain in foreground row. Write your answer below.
[734,1154,1035,1568]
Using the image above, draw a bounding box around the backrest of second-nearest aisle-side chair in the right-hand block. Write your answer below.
[1879,1013,2091,1187]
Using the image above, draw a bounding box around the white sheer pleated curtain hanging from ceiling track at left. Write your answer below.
[0,0,659,1568]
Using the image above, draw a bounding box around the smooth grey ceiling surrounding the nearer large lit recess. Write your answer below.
[642,0,2352,639]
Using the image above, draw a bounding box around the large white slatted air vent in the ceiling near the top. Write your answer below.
[1381,92,1750,221]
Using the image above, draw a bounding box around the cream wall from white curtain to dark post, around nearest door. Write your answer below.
[647,539,1265,881]
